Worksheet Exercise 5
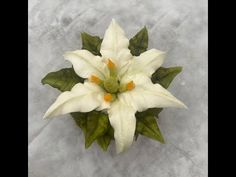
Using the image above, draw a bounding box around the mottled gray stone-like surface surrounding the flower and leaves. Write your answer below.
[28,0,208,177]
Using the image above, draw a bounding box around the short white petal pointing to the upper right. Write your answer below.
[127,49,165,77]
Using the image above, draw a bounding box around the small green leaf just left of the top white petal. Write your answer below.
[81,32,102,56]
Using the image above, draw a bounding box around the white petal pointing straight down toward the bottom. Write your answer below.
[108,100,136,153]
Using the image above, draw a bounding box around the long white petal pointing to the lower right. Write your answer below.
[119,75,186,111]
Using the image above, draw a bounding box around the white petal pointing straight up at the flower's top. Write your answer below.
[100,19,132,68]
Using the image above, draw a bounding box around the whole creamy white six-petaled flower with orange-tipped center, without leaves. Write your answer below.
[44,20,186,153]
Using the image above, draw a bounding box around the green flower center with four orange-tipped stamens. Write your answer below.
[89,59,135,102]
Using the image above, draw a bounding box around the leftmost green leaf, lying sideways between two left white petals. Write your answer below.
[41,68,84,92]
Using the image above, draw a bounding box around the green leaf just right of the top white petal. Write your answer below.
[129,27,148,56]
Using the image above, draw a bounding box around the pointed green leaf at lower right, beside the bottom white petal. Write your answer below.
[136,116,165,143]
